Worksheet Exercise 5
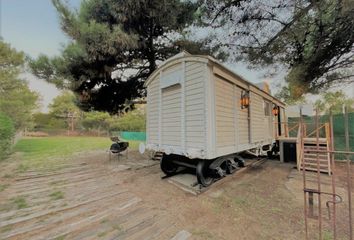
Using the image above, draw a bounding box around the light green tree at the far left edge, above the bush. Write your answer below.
[0,41,39,129]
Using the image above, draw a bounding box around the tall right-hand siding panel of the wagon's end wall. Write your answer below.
[185,62,206,149]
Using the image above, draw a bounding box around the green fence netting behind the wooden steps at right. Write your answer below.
[288,112,354,160]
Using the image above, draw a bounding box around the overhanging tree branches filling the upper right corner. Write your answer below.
[202,0,354,98]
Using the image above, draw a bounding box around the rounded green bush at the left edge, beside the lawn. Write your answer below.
[0,113,15,160]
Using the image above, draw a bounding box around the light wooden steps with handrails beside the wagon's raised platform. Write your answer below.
[297,123,331,175]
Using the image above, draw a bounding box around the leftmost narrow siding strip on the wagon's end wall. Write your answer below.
[147,77,159,143]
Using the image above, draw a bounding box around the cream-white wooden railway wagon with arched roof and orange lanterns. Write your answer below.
[145,52,285,186]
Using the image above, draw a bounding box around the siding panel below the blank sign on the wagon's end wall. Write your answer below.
[161,84,181,146]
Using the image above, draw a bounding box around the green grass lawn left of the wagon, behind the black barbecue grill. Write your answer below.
[14,137,139,172]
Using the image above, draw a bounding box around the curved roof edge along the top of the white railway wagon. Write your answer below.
[144,51,286,107]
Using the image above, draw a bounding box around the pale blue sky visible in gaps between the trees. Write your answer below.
[0,0,354,111]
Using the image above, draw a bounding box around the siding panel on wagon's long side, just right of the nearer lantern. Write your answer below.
[250,92,269,142]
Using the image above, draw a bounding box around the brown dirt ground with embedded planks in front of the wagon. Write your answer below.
[0,151,348,240]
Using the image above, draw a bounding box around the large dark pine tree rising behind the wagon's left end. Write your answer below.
[30,0,216,113]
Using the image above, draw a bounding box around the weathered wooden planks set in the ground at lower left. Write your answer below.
[0,154,188,239]
